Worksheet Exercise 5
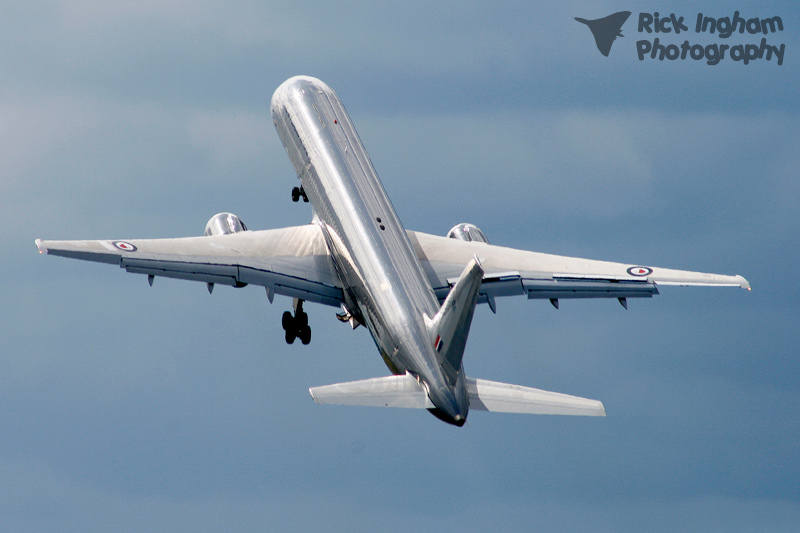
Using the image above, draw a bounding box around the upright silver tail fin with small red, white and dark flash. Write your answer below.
[426,258,483,383]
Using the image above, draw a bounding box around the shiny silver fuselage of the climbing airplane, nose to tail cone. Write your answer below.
[272,76,469,425]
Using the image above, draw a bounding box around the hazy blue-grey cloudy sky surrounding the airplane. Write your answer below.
[0,1,800,531]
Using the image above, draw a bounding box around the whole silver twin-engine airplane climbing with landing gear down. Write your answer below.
[36,76,750,426]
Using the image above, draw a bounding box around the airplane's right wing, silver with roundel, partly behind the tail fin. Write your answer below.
[408,231,750,310]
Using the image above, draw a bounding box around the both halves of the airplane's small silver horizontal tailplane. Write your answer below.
[309,374,606,416]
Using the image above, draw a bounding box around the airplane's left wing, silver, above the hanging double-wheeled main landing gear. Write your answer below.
[36,224,343,307]
